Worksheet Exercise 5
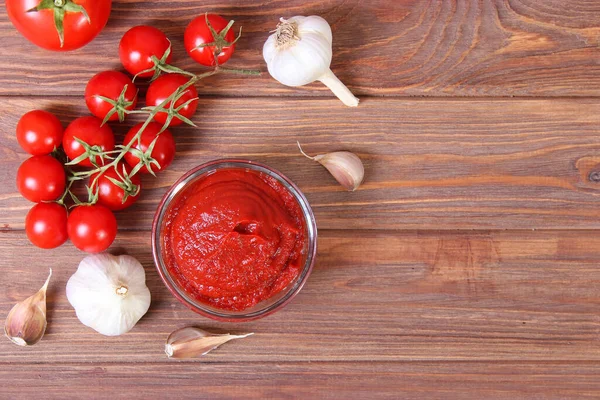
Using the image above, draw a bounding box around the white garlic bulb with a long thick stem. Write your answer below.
[263,15,358,107]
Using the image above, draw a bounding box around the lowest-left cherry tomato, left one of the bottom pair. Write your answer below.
[25,203,68,249]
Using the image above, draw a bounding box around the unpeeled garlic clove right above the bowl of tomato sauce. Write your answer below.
[297,142,365,191]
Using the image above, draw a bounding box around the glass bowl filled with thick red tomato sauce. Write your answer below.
[153,160,316,320]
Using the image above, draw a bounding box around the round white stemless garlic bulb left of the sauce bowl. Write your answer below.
[67,254,150,336]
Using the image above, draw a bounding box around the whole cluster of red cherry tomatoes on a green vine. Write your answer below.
[17,14,237,252]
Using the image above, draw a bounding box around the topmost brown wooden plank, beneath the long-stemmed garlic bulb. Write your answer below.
[0,0,600,96]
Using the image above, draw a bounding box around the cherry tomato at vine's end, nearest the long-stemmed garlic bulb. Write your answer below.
[183,14,235,67]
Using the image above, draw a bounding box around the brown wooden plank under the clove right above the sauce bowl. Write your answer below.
[0,98,600,229]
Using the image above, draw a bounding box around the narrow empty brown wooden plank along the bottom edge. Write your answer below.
[0,362,600,399]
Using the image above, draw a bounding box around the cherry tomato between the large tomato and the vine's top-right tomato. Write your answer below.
[119,25,171,78]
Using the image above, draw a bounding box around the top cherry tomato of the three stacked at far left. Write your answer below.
[17,110,64,156]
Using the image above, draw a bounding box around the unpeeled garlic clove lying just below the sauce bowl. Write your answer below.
[165,327,254,358]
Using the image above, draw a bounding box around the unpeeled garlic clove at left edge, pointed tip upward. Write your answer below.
[4,269,52,346]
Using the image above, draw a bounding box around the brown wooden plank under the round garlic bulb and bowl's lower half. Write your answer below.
[0,231,600,368]
